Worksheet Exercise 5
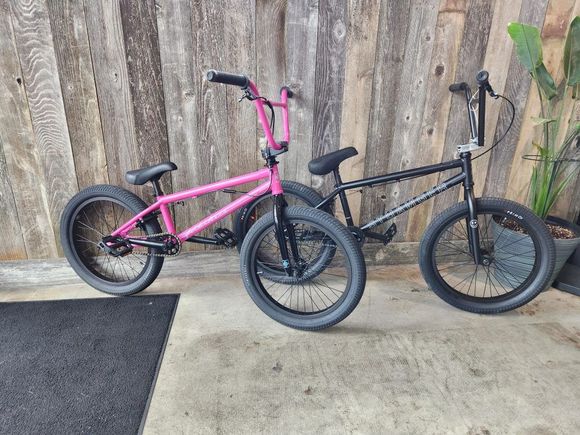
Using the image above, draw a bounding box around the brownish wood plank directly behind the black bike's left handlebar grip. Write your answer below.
[433,0,496,215]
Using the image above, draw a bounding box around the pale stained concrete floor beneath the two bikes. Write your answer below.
[0,257,580,435]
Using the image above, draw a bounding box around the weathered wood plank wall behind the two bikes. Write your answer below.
[0,0,580,259]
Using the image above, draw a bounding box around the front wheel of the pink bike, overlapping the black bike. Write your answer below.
[240,207,366,330]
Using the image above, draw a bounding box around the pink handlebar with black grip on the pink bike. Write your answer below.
[206,69,294,151]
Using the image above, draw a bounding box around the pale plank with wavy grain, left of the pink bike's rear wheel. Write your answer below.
[12,0,78,253]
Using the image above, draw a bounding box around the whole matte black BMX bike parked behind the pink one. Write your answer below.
[235,71,555,314]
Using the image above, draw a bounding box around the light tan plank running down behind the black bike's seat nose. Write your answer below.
[336,0,381,223]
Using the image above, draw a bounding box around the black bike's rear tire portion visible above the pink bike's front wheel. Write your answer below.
[234,180,332,250]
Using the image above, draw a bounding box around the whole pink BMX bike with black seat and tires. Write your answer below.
[61,70,366,330]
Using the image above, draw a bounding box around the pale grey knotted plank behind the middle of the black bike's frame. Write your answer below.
[376,0,439,241]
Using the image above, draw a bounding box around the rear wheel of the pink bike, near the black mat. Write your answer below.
[60,185,163,296]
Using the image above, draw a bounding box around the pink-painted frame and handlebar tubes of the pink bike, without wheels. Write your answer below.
[111,81,290,242]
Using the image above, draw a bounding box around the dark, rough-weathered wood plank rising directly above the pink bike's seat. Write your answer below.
[120,0,171,199]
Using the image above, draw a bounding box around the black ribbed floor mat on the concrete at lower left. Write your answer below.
[0,295,179,434]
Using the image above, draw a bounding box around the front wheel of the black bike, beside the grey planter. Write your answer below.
[419,198,555,314]
